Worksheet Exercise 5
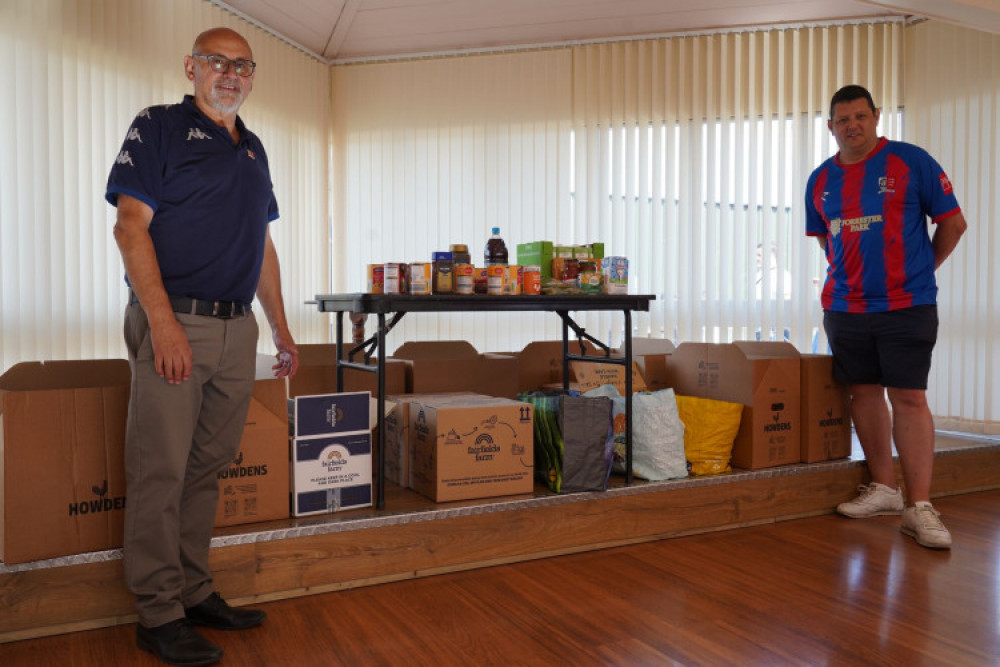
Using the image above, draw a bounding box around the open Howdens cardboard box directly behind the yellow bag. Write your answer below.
[667,341,801,470]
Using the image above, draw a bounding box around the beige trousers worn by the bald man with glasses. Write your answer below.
[124,304,258,627]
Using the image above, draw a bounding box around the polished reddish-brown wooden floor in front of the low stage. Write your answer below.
[0,490,1000,667]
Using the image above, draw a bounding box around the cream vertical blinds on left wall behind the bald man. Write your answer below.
[0,0,330,372]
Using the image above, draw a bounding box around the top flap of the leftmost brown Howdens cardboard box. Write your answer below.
[0,359,132,391]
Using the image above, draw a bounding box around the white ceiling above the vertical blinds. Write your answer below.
[212,0,1000,62]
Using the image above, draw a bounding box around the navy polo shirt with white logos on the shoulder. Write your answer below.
[105,95,278,304]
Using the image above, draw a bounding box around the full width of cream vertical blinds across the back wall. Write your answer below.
[333,22,903,358]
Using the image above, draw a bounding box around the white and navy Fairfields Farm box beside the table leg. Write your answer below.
[291,391,376,516]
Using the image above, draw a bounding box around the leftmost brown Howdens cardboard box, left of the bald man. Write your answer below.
[0,359,131,564]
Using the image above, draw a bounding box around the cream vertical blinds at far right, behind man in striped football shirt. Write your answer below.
[905,21,1000,434]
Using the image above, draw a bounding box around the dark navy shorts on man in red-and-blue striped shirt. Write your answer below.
[823,306,938,389]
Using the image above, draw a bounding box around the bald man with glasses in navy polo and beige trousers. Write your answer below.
[105,28,298,665]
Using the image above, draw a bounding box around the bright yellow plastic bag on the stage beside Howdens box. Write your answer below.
[677,396,743,475]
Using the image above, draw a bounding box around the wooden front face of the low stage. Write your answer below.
[0,441,1000,642]
